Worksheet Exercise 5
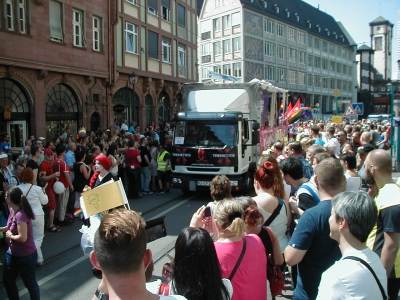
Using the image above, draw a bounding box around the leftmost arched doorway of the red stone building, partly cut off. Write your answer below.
[0,78,29,149]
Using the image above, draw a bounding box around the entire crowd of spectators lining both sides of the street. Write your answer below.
[0,118,400,300]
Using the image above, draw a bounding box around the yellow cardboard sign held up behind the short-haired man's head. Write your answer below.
[81,180,129,217]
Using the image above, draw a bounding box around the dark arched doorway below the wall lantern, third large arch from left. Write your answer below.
[112,87,139,125]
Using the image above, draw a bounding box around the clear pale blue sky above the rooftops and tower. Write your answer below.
[303,0,400,79]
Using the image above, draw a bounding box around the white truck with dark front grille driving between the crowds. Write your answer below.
[171,80,287,192]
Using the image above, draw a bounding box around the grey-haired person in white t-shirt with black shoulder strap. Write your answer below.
[317,191,387,300]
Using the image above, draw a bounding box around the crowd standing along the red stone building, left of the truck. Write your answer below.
[0,120,175,299]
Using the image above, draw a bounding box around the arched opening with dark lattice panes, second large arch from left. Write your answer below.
[45,83,79,141]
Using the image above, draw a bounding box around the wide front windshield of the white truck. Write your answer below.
[174,121,237,147]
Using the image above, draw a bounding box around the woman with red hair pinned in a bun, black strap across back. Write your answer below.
[253,161,289,253]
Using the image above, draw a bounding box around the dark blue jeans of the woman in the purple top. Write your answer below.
[3,250,40,300]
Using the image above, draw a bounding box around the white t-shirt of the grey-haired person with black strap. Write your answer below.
[317,248,387,300]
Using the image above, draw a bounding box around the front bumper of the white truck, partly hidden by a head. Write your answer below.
[170,173,248,192]
